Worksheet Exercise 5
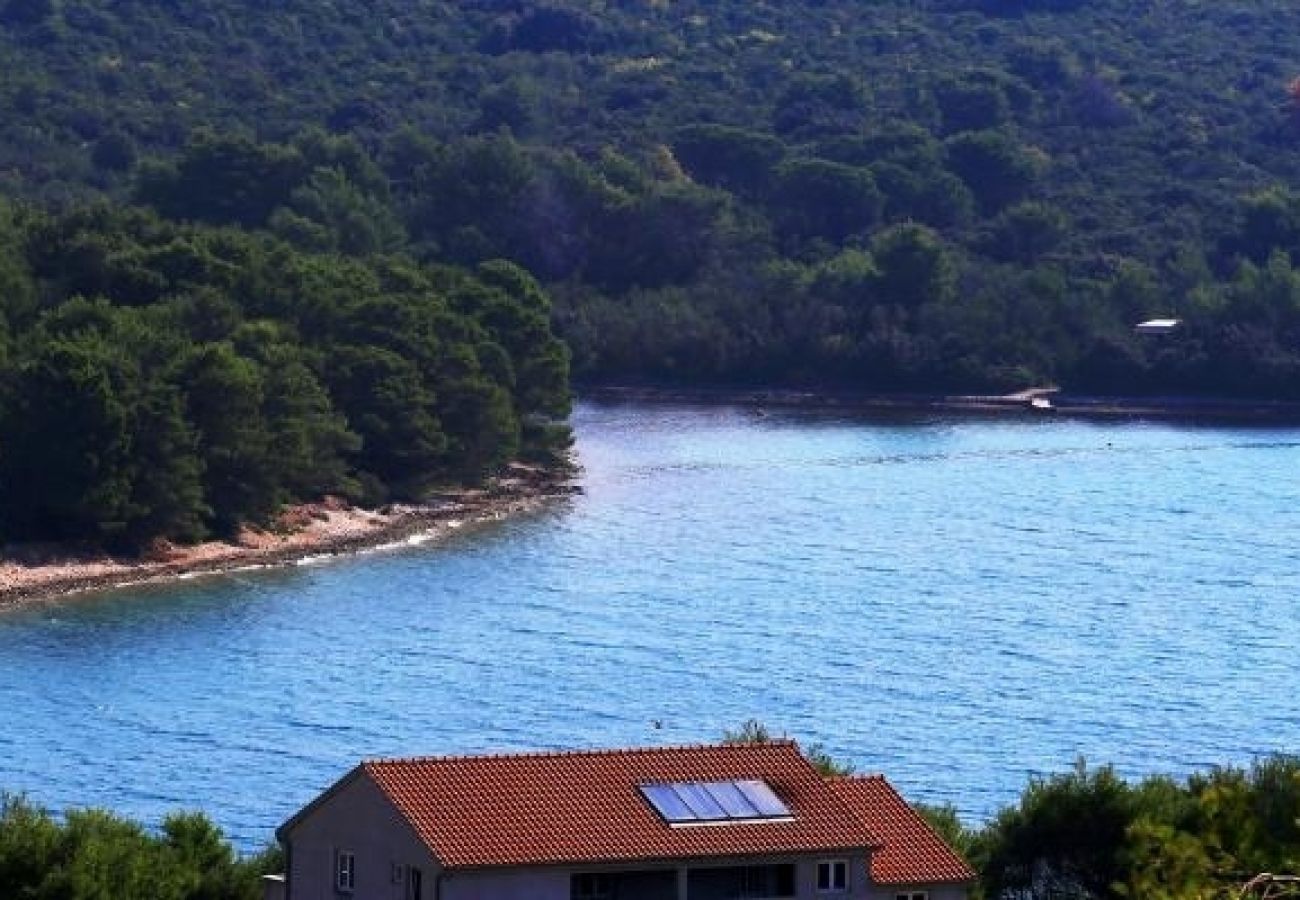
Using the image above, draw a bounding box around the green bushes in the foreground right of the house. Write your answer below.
[946,756,1300,900]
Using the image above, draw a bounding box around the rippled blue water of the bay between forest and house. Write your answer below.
[0,404,1300,847]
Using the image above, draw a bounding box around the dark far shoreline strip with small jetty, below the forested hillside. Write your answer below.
[577,384,1300,425]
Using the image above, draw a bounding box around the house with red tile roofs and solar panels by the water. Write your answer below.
[268,741,974,900]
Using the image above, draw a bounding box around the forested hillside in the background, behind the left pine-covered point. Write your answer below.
[0,0,1300,398]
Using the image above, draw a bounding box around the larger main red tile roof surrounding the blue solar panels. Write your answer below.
[360,741,878,869]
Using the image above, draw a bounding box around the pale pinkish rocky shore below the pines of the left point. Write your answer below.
[0,466,577,615]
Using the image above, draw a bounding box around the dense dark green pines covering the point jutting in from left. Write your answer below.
[0,193,568,548]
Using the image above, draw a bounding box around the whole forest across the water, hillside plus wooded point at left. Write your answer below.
[0,0,1300,535]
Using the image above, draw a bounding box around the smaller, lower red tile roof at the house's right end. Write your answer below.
[829,775,975,884]
